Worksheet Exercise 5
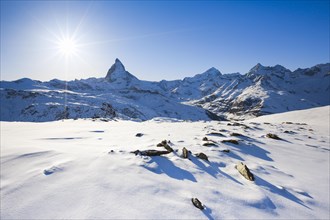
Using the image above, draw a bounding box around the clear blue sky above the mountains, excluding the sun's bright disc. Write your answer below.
[1,1,330,81]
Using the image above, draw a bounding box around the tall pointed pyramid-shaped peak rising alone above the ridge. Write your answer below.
[104,58,137,83]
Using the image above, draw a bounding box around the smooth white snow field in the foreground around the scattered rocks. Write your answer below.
[1,106,330,219]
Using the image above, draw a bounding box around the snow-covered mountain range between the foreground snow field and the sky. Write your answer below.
[0,59,330,122]
